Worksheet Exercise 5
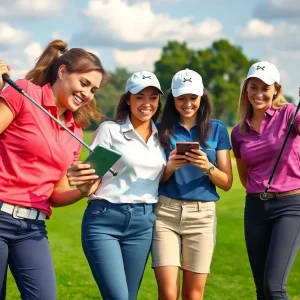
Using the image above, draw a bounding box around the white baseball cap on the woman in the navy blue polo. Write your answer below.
[171,69,204,97]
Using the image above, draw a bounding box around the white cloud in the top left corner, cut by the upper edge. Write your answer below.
[0,0,68,20]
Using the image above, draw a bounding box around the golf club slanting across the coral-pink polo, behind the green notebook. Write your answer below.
[2,74,118,176]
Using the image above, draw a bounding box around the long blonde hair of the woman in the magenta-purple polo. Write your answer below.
[238,79,288,134]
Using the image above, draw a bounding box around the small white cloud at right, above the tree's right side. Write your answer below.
[237,19,275,39]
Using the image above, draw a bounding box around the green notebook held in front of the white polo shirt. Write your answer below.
[84,145,122,178]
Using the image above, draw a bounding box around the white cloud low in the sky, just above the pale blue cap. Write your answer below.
[114,48,162,72]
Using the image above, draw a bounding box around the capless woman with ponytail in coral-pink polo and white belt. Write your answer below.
[0,40,106,300]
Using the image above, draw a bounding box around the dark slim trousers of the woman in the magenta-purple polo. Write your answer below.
[245,195,300,300]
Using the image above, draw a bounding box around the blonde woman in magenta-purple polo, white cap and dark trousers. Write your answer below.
[231,61,300,300]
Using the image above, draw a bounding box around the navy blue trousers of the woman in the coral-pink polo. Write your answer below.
[0,202,56,300]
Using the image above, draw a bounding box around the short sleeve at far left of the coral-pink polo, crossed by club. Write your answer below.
[0,79,28,118]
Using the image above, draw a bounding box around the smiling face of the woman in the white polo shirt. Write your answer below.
[127,86,159,127]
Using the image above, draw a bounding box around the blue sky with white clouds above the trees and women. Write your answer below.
[0,0,300,102]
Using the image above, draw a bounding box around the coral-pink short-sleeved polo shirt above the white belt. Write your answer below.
[0,80,83,217]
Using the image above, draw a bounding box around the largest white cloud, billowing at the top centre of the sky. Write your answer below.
[75,0,223,49]
